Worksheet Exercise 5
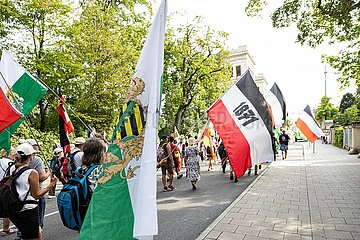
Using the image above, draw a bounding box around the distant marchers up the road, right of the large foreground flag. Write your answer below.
[157,130,290,192]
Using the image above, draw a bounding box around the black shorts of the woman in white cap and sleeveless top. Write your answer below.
[10,207,39,239]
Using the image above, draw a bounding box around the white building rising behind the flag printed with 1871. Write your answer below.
[228,46,268,94]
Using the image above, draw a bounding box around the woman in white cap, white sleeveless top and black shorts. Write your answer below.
[10,143,57,239]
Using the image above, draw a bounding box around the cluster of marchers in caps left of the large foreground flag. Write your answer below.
[0,137,107,240]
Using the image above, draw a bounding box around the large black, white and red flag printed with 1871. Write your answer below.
[208,71,274,177]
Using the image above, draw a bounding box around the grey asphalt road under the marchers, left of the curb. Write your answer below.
[0,159,265,240]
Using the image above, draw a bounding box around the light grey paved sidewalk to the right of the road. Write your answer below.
[198,141,360,240]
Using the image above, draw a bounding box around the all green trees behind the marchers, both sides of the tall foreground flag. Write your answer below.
[0,0,232,142]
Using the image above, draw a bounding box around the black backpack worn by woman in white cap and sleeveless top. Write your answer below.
[0,166,38,218]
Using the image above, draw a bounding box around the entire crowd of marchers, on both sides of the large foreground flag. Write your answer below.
[0,127,290,239]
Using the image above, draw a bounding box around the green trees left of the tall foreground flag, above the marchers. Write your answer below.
[0,0,151,139]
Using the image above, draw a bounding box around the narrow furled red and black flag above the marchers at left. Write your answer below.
[58,94,74,154]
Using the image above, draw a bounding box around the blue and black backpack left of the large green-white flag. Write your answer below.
[57,165,99,230]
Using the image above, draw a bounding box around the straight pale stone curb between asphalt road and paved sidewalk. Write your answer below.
[196,162,273,240]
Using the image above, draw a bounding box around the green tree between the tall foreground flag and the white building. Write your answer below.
[160,17,231,133]
